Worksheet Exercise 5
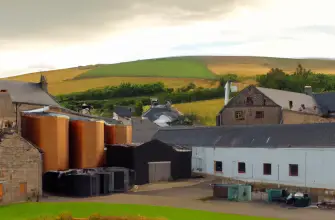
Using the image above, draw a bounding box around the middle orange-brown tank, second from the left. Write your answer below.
[69,120,105,169]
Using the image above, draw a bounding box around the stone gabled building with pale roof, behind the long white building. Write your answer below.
[216,85,331,126]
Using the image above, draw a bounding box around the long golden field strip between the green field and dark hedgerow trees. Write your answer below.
[49,77,217,95]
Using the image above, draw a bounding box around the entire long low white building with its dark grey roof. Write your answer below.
[153,123,335,189]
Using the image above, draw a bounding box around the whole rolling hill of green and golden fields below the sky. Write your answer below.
[8,56,335,95]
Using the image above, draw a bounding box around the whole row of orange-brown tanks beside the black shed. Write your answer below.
[21,112,132,172]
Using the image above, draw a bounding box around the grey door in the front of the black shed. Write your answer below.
[148,161,171,183]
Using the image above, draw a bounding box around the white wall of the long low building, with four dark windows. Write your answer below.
[192,147,335,189]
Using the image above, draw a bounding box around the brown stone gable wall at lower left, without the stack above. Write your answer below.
[0,133,42,205]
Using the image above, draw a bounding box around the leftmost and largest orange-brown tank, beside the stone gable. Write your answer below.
[21,113,69,172]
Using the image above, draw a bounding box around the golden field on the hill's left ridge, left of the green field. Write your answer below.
[8,67,91,84]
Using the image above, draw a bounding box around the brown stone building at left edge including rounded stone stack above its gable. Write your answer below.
[0,90,42,204]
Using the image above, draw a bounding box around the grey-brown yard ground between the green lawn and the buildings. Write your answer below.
[44,181,335,220]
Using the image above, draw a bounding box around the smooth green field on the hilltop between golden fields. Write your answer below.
[76,58,216,79]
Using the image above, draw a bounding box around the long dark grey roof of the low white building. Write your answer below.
[153,123,335,148]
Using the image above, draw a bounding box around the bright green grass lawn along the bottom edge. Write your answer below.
[0,202,280,220]
